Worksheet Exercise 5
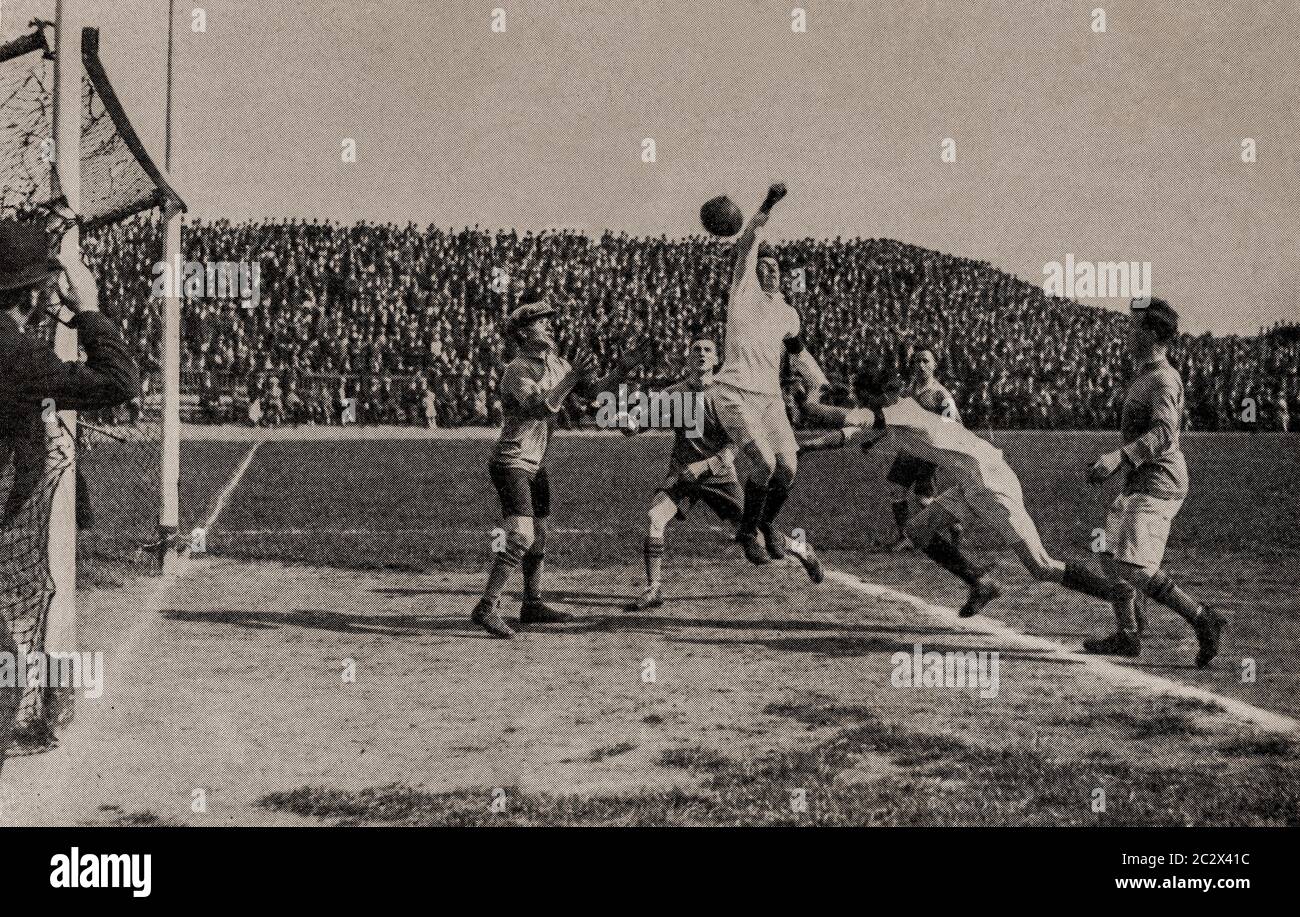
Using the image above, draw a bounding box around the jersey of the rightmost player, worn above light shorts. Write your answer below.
[1119,358,1188,499]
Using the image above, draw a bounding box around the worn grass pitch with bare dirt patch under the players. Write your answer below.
[22,433,1300,825]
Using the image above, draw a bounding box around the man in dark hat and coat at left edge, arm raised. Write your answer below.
[0,220,139,523]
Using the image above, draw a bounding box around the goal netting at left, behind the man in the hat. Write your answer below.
[0,22,183,761]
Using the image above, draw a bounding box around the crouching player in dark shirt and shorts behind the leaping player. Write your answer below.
[621,338,824,609]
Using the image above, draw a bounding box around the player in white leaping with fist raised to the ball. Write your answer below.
[714,182,802,565]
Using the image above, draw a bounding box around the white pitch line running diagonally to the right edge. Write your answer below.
[826,568,1300,732]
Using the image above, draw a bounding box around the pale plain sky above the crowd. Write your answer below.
[0,0,1300,333]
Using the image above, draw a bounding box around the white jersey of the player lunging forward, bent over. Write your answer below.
[845,398,1011,486]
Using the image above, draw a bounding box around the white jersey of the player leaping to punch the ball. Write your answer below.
[714,253,800,395]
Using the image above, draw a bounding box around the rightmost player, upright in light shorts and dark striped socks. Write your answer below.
[1083,298,1227,667]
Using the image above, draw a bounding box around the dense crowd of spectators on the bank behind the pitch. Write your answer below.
[87,213,1300,429]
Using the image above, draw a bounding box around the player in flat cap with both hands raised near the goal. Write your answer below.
[469,294,641,640]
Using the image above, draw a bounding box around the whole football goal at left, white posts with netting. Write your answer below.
[0,10,185,762]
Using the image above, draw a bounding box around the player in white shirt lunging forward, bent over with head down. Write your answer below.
[801,369,1113,618]
